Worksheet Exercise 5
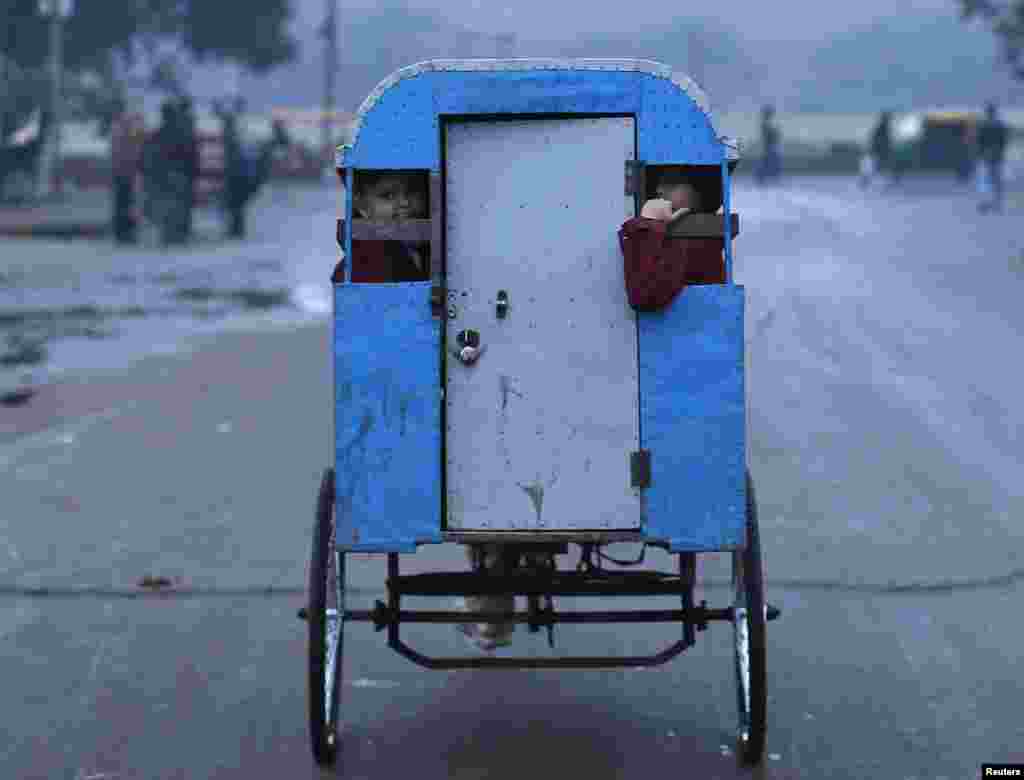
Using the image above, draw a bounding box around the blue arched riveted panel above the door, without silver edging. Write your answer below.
[343,70,723,171]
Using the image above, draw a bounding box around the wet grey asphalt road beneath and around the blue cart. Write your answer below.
[0,172,1024,780]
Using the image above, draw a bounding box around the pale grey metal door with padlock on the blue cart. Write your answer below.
[445,118,641,531]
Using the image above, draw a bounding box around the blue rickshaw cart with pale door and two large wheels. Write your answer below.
[300,59,778,766]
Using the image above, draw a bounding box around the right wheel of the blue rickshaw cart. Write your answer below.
[732,470,768,767]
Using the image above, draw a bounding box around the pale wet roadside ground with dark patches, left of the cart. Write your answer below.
[0,182,340,395]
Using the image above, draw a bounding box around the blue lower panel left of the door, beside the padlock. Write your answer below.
[334,283,441,553]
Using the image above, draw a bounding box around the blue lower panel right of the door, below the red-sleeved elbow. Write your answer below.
[638,285,746,552]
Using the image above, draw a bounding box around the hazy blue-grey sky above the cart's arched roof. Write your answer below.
[184,0,1024,113]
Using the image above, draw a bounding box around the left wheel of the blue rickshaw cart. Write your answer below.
[307,469,345,767]
